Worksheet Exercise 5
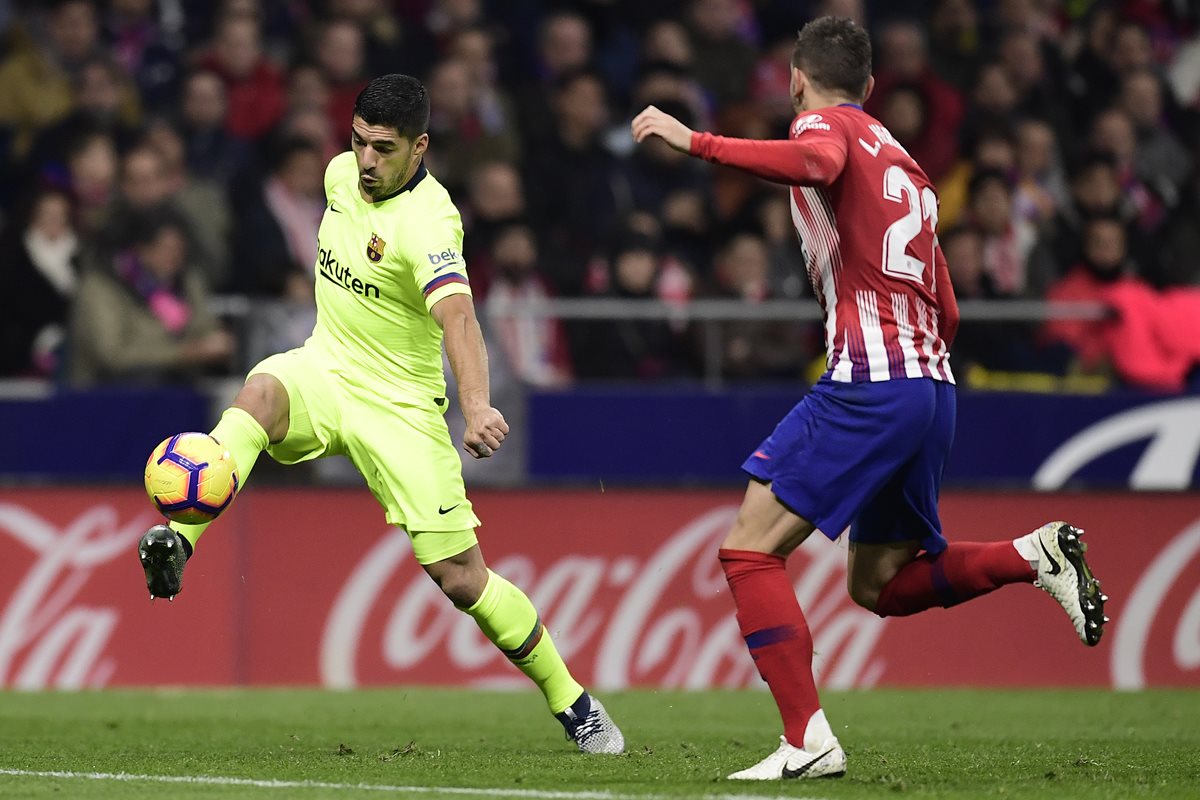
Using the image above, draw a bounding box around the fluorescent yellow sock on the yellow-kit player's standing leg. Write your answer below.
[466,570,583,714]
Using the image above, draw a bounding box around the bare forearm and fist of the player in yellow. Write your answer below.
[430,294,509,458]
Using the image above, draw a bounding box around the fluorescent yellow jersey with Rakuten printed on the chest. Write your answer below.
[307,152,470,404]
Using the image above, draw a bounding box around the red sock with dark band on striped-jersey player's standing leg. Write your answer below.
[718,549,821,747]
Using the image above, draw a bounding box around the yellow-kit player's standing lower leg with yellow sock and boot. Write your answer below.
[463,570,625,754]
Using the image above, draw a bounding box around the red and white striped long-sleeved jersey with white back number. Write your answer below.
[691,104,958,383]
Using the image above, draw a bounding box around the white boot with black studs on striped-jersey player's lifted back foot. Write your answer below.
[1015,522,1109,646]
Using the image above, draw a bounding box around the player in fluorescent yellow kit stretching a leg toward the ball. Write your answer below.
[138,74,624,753]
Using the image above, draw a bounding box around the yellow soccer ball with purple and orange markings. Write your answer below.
[145,433,238,525]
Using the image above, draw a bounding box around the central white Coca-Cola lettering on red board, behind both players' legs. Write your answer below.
[319,506,887,688]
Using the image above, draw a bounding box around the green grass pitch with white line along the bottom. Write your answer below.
[0,687,1200,800]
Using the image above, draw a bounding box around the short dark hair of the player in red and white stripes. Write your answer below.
[792,17,871,101]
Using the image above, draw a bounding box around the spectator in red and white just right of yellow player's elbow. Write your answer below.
[484,222,571,389]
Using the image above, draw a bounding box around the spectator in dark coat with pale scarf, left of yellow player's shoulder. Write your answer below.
[232,139,325,302]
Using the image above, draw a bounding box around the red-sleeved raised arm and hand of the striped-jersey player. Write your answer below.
[632,106,846,186]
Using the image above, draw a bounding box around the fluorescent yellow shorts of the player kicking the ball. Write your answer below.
[247,347,480,564]
